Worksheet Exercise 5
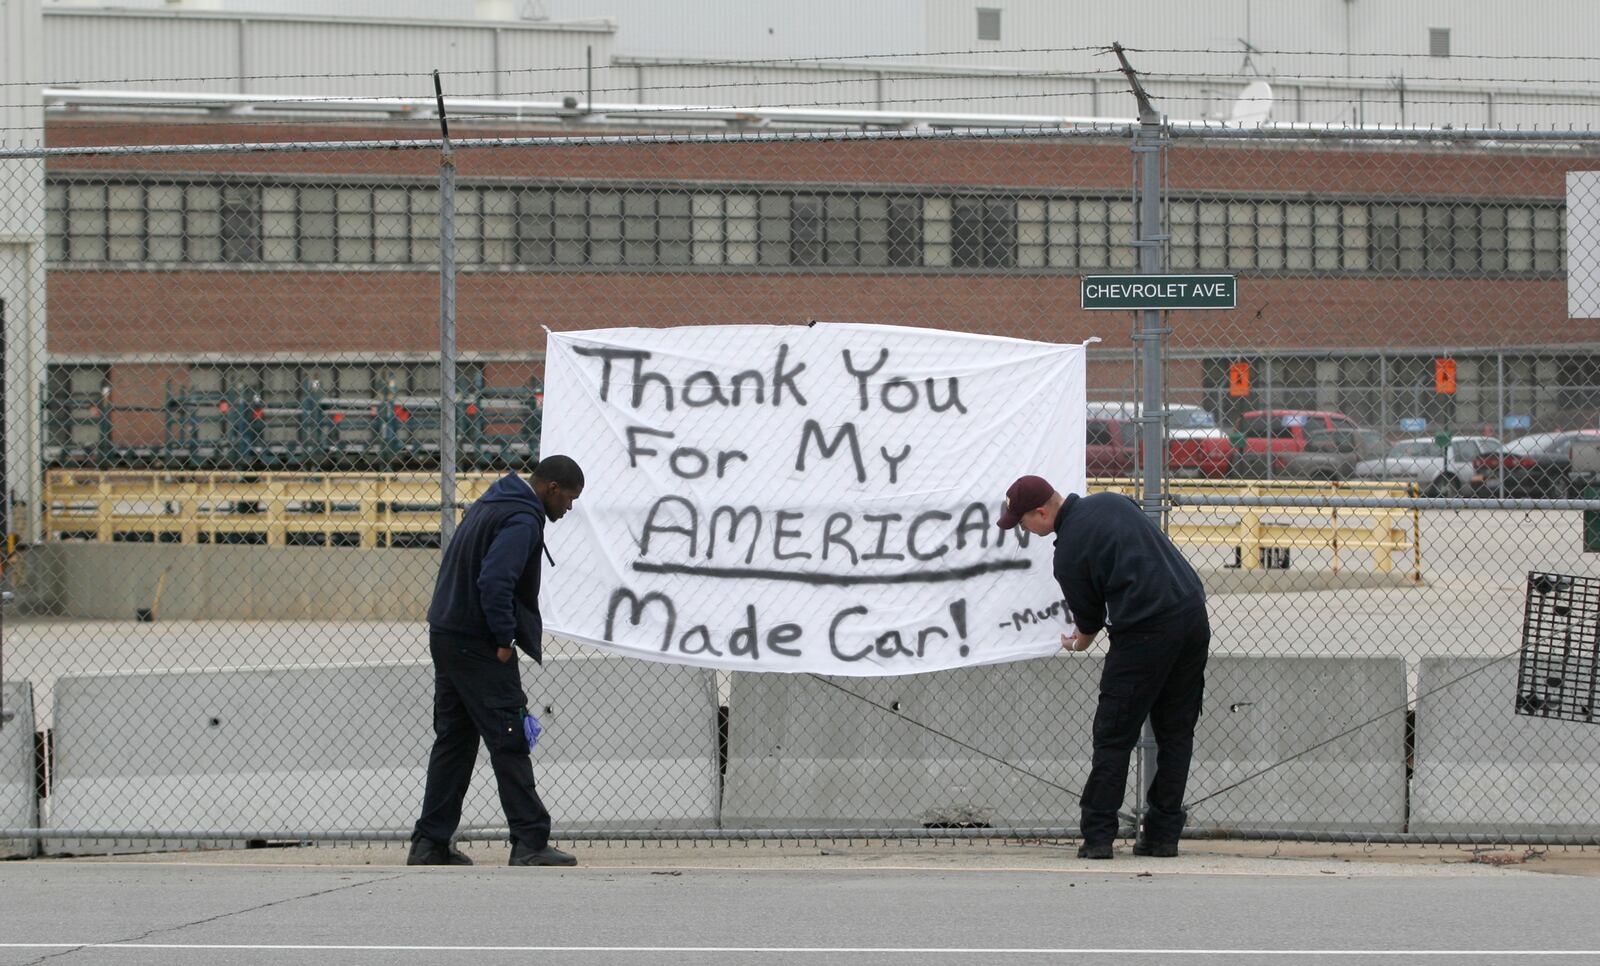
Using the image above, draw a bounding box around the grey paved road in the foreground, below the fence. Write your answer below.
[0,841,1600,966]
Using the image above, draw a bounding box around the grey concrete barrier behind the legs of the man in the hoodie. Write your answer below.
[50,657,717,838]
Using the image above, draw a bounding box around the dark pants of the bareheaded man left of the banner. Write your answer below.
[413,635,550,849]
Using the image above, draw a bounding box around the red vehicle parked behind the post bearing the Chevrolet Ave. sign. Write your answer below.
[1085,403,1234,480]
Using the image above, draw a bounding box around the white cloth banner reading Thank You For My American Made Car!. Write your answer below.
[539,325,1085,675]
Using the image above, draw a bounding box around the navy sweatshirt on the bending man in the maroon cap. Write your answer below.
[1056,493,1205,633]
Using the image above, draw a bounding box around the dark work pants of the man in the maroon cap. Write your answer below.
[1078,608,1211,843]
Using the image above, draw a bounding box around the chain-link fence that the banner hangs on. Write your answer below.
[0,115,1600,851]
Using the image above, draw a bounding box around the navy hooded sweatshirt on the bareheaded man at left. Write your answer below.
[427,473,544,661]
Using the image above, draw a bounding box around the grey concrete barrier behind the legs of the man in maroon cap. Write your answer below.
[723,654,1405,830]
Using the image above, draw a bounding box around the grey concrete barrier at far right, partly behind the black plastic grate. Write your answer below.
[1411,657,1600,835]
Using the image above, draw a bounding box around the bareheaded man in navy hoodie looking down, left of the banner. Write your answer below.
[406,456,584,865]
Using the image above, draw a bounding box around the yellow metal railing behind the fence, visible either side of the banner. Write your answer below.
[43,470,1421,579]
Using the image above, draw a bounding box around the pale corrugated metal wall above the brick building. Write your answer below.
[31,0,1600,126]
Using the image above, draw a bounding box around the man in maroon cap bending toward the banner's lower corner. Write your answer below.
[1000,477,1211,859]
